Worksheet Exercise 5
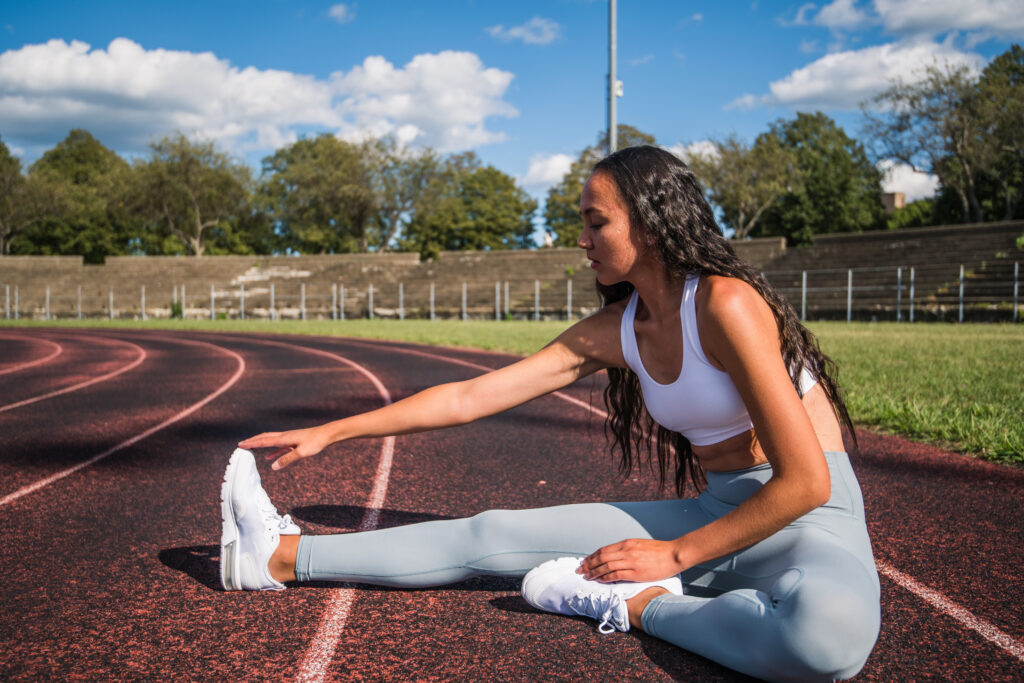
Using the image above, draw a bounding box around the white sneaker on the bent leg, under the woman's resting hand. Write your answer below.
[522,557,683,634]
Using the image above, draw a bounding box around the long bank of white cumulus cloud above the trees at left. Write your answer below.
[0,38,517,158]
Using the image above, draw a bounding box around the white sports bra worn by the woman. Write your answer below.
[620,274,815,445]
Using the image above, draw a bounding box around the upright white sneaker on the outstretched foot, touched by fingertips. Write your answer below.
[220,449,301,591]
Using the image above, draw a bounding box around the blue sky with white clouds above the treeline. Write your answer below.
[0,0,1024,224]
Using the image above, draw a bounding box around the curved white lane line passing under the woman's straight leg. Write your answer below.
[214,337,395,683]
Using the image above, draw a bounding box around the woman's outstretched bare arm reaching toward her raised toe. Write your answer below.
[239,306,622,469]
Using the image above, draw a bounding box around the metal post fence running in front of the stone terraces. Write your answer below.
[0,260,1020,323]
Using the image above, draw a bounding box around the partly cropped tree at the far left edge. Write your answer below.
[0,140,61,256]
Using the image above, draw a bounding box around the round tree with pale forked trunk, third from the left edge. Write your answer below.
[133,133,251,256]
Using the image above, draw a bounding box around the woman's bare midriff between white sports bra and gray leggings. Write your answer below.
[693,384,846,472]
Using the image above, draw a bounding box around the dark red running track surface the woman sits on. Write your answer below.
[0,329,1024,681]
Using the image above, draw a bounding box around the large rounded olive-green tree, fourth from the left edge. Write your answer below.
[260,133,376,254]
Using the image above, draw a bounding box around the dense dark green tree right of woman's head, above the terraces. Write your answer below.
[752,112,885,244]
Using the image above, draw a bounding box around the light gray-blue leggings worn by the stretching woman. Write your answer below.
[296,453,880,681]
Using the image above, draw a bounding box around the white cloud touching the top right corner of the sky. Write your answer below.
[874,0,1024,37]
